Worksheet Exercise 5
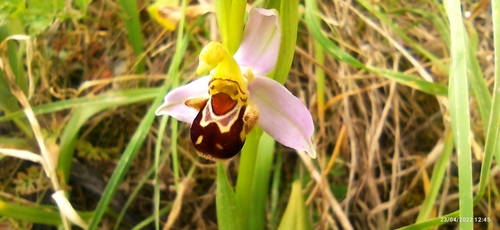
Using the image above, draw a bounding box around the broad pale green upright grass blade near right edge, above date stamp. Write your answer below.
[447,0,474,229]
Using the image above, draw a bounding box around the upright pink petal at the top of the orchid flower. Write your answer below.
[234,8,281,75]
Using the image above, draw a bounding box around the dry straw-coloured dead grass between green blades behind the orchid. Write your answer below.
[0,0,500,229]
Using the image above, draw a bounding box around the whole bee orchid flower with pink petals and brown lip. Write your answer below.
[156,8,316,160]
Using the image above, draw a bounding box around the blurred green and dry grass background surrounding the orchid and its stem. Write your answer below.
[0,0,500,229]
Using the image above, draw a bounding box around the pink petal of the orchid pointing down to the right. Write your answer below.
[249,76,316,158]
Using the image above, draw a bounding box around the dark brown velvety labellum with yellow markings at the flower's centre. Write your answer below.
[186,93,258,161]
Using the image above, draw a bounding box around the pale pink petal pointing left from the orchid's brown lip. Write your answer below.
[156,76,211,123]
